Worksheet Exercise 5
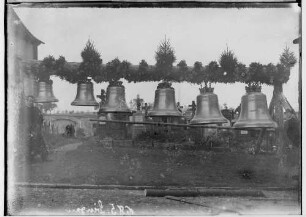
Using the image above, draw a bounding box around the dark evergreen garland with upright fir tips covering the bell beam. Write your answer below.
[37,42,297,90]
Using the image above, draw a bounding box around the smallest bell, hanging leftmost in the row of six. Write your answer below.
[35,81,58,103]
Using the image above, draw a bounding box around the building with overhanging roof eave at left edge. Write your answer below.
[5,6,43,158]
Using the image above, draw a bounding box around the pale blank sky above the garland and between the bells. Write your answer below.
[15,8,299,111]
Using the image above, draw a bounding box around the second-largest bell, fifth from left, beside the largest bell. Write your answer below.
[190,92,228,124]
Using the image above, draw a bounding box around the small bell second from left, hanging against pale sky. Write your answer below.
[71,82,99,106]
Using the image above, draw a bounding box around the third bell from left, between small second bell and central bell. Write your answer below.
[99,86,131,113]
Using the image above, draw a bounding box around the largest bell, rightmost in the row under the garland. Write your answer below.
[234,92,277,129]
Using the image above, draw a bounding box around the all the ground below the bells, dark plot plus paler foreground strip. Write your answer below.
[8,138,301,215]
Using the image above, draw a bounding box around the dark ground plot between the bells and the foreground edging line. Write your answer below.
[16,136,299,188]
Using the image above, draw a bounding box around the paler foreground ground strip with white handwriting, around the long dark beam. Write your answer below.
[9,188,301,216]
